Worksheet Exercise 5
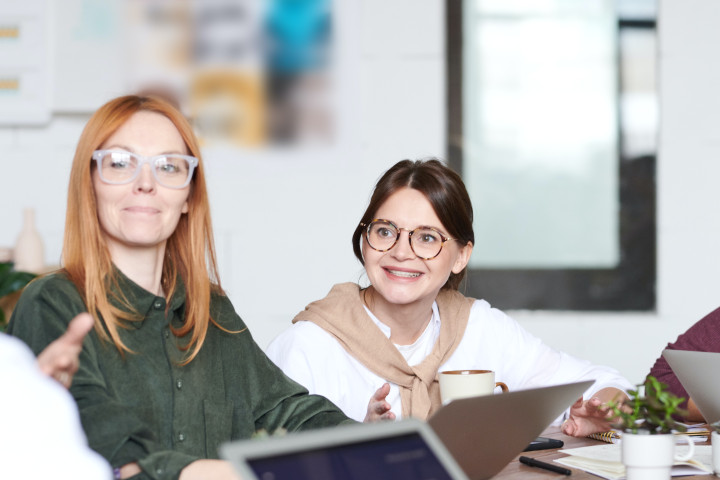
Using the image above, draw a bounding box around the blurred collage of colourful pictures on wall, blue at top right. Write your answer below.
[128,0,334,147]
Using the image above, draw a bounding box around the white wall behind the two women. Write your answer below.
[0,0,720,382]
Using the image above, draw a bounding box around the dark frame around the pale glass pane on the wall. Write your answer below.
[446,0,656,311]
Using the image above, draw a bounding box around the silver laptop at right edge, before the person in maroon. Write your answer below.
[663,349,720,423]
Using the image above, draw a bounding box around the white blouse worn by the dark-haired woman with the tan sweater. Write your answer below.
[266,300,633,422]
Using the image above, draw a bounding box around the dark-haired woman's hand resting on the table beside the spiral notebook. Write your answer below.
[561,388,625,437]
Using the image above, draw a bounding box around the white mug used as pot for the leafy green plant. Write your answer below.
[621,433,695,480]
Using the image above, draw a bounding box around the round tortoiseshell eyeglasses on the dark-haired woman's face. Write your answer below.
[360,218,455,260]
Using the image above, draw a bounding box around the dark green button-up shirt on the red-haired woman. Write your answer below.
[8,270,350,479]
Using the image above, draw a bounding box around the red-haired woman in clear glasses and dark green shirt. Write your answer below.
[9,96,349,479]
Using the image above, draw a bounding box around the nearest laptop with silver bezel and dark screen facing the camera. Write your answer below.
[220,419,467,480]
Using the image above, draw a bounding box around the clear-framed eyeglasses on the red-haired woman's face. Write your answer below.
[92,150,198,188]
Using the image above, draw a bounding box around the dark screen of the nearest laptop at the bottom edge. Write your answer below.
[248,433,452,480]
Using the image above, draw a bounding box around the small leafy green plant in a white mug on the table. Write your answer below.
[609,376,694,480]
